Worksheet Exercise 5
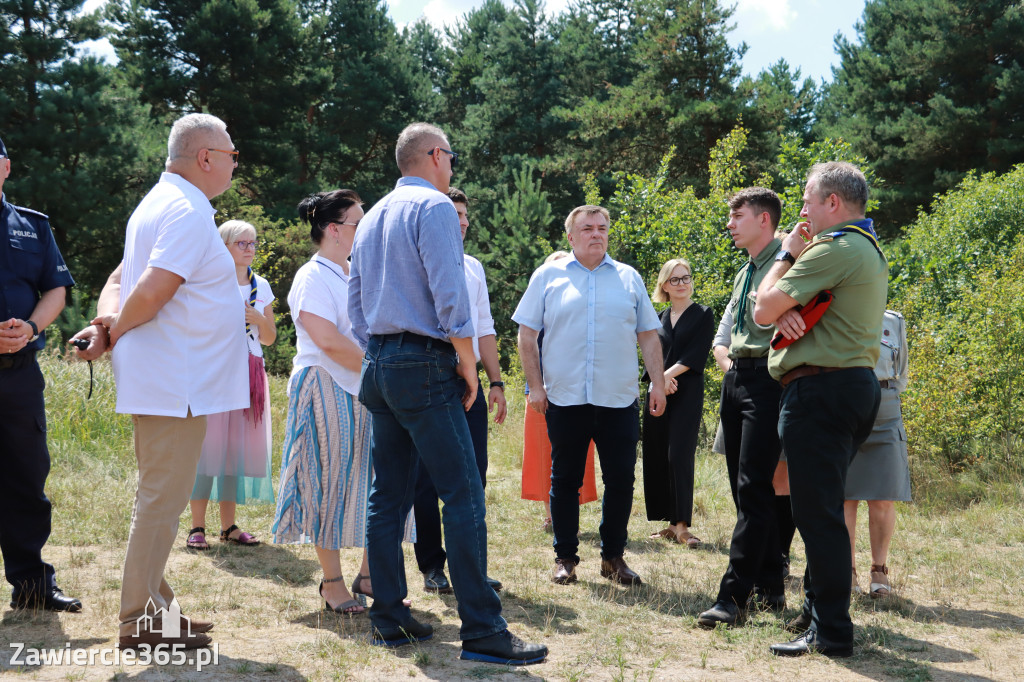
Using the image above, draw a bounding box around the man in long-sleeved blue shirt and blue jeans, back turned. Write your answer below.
[348,123,548,665]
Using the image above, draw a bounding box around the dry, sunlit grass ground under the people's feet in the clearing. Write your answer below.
[0,352,1024,680]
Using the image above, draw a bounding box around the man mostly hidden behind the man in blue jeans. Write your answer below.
[414,187,507,594]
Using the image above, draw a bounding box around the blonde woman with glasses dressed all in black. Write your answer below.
[643,258,715,548]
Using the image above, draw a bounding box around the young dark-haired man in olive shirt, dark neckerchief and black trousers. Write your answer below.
[697,187,785,628]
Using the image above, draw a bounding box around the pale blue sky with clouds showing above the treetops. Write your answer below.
[77,0,864,81]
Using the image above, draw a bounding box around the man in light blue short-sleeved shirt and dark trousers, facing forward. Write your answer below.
[512,206,665,585]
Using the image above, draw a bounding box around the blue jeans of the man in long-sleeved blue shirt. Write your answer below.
[359,332,507,639]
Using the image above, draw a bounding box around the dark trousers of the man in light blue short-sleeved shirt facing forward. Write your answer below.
[546,401,640,563]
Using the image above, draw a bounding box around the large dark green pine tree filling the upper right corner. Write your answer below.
[820,0,1024,232]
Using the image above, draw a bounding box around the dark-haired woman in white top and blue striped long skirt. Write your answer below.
[272,189,413,614]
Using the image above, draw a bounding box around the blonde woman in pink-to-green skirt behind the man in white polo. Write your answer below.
[185,220,278,550]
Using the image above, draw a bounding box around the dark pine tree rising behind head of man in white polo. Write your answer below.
[106,0,304,205]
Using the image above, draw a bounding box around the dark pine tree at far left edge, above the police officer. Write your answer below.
[0,0,155,292]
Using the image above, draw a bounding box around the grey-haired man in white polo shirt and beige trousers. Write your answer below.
[77,114,249,648]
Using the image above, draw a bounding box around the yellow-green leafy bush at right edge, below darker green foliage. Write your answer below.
[902,231,1024,471]
